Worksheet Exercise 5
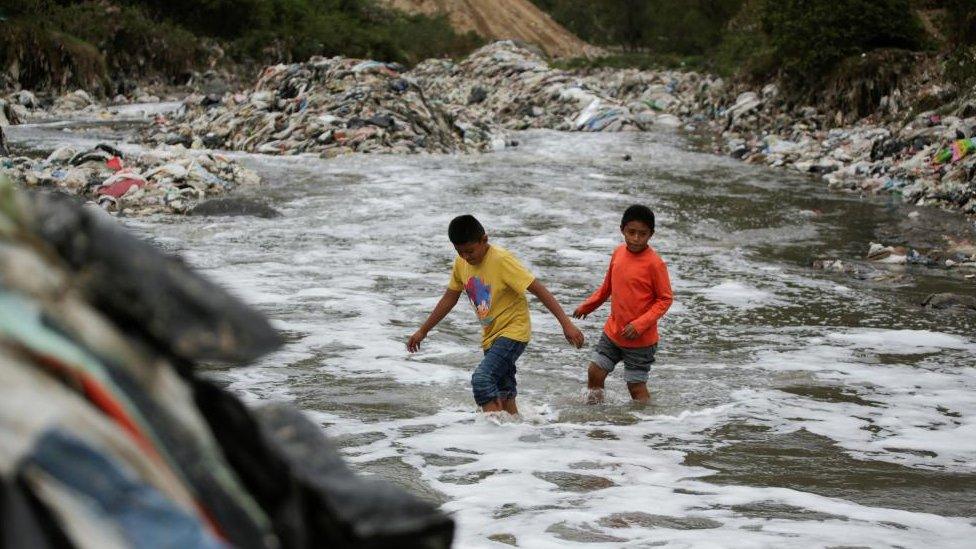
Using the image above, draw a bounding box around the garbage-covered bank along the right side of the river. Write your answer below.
[585,63,976,215]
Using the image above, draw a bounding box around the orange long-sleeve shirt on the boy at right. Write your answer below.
[580,244,674,348]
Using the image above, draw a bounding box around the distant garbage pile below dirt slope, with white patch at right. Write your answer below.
[411,40,655,132]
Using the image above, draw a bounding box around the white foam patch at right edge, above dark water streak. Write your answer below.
[737,329,976,472]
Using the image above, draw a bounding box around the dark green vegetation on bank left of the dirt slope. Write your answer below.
[0,0,480,93]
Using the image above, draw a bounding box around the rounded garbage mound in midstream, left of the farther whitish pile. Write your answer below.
[147,57,498,156]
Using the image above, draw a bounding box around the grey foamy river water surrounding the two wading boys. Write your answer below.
[10,121,976,548]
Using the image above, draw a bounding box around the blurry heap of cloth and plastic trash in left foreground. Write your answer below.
[0,178,453,549]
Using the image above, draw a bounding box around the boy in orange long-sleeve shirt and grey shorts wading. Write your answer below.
[573,204,672,404]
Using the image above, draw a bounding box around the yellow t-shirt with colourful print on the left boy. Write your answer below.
[447,245,535,349]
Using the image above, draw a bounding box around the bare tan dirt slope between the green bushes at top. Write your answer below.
[386,0,598,57]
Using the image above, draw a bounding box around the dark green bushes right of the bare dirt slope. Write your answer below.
[533,0,976,87]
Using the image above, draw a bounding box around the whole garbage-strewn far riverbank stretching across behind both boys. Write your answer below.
[1,41,976,274]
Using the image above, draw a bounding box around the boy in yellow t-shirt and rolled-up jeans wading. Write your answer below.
[407,215,583,415]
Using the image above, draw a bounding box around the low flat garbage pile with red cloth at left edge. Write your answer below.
[0,143,260,215]
